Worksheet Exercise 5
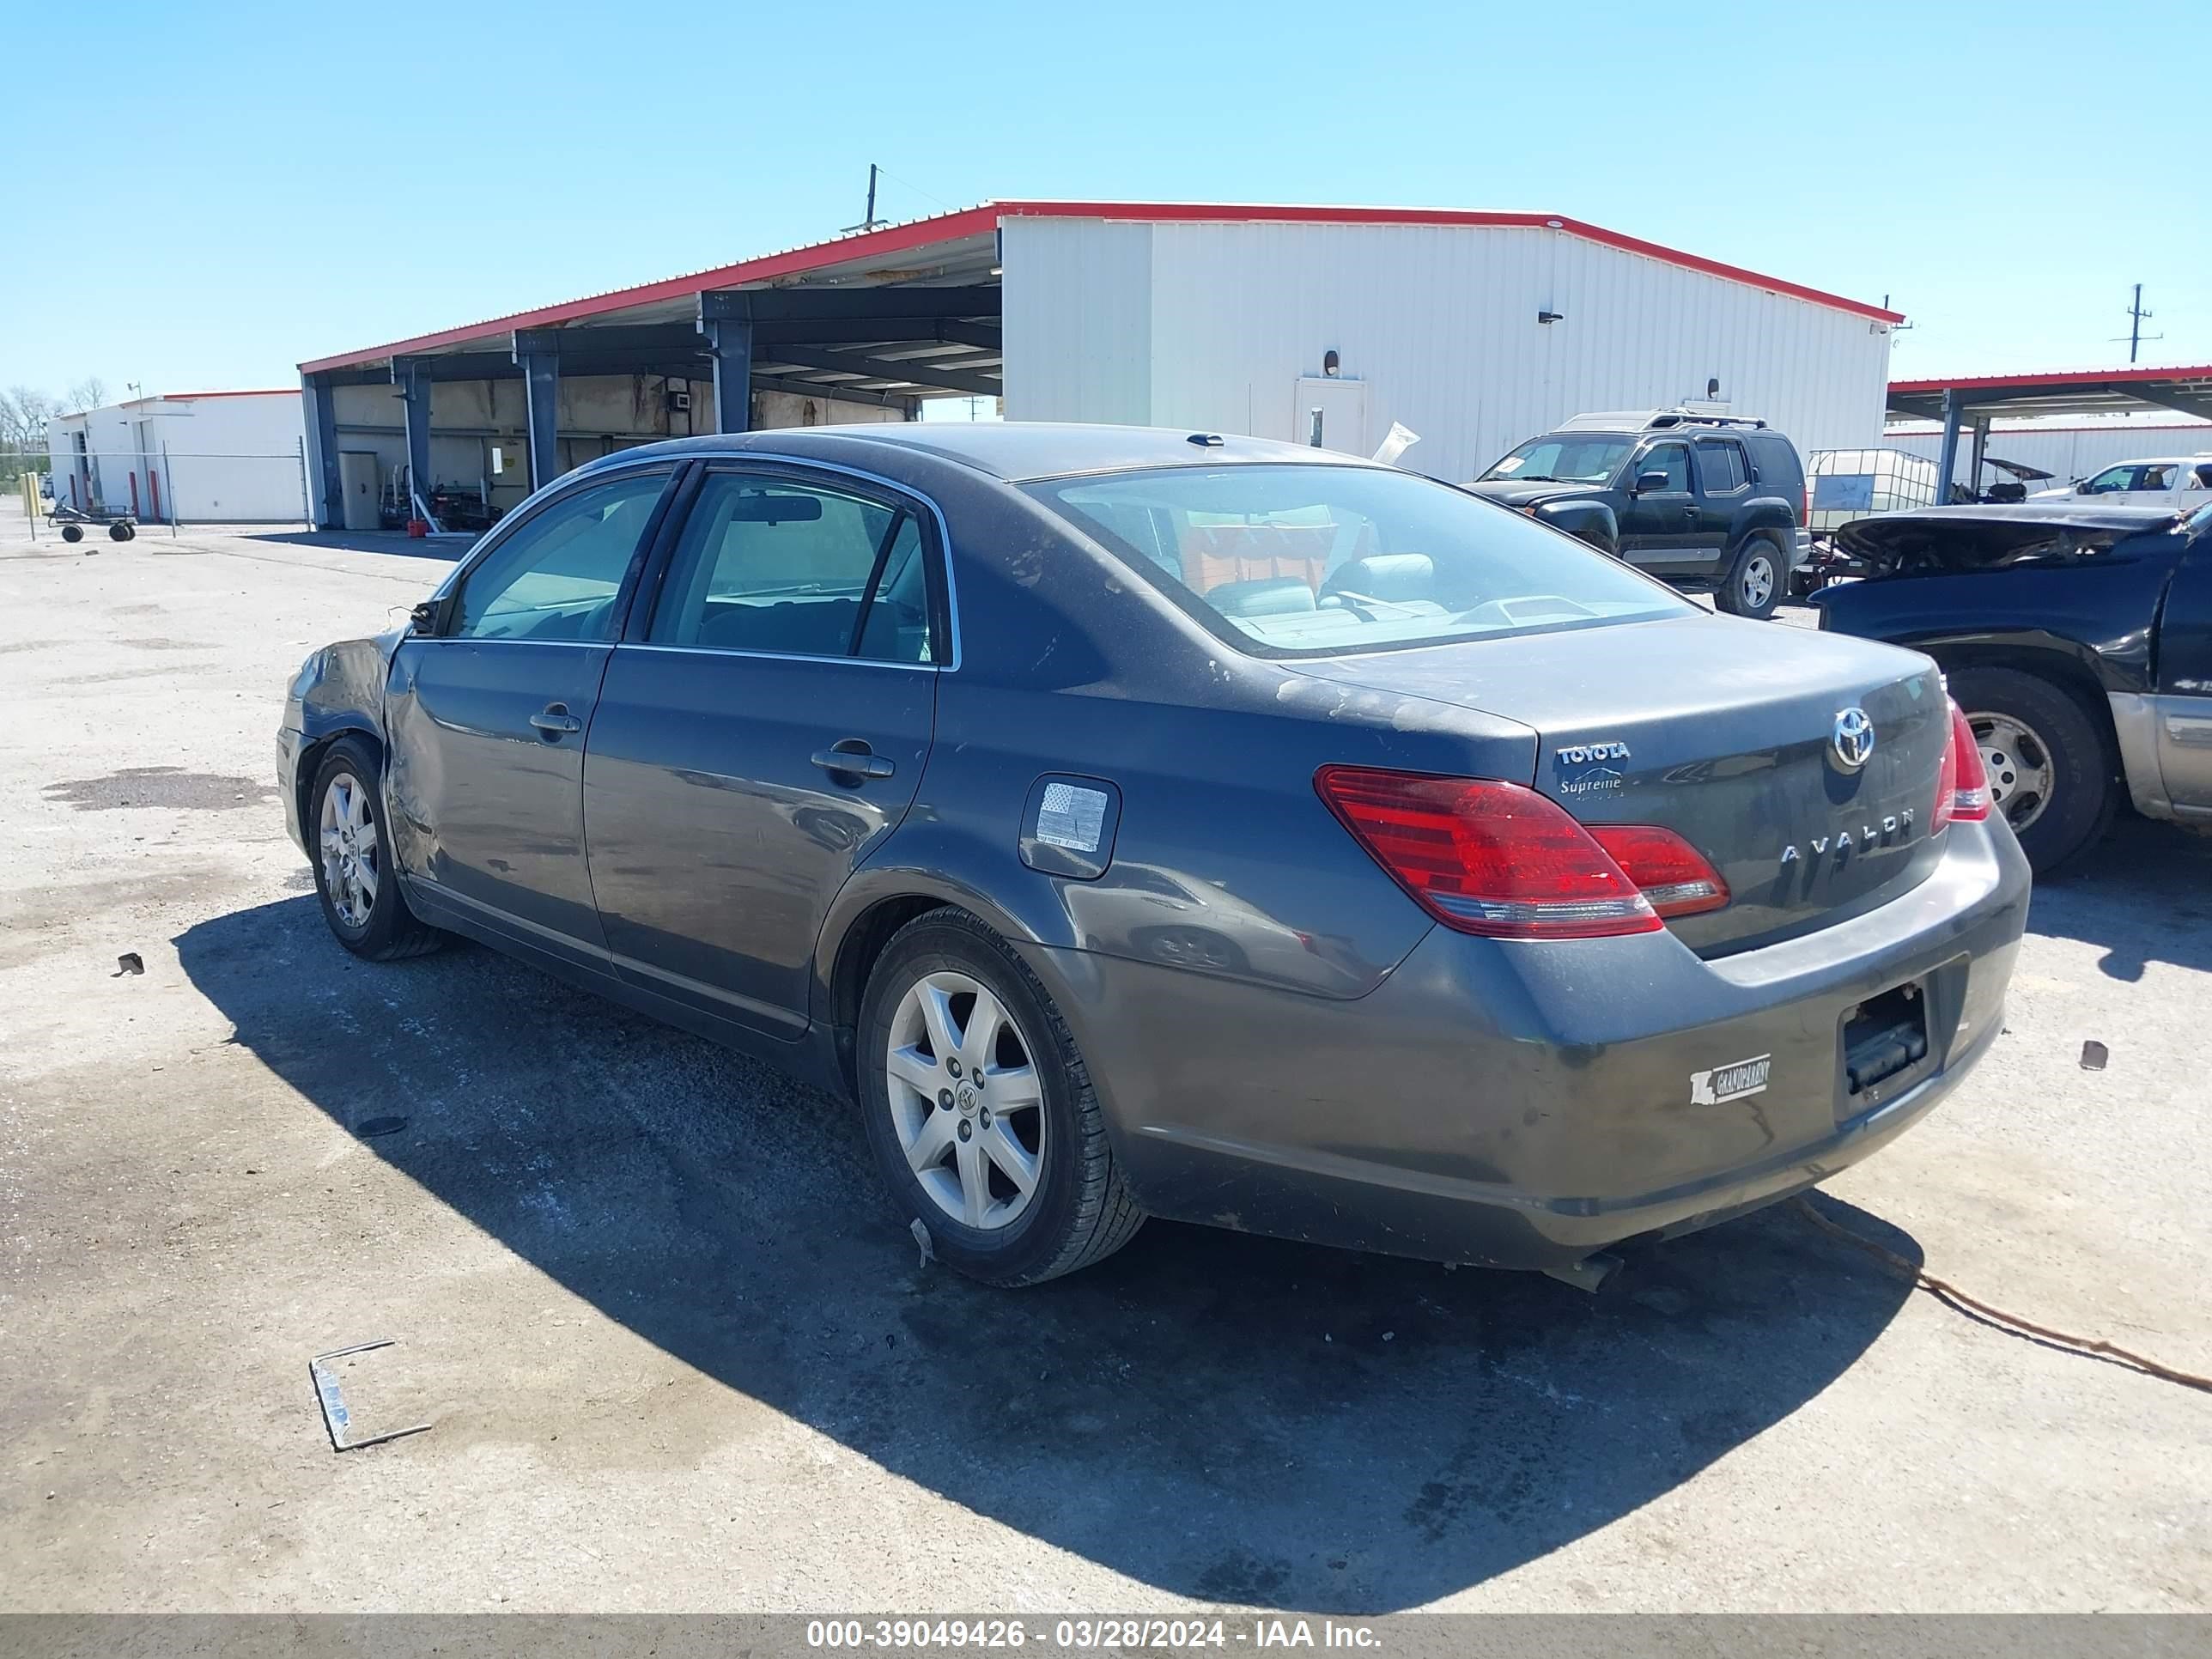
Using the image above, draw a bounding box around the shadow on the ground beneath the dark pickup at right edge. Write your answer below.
[2028,811,2212,984]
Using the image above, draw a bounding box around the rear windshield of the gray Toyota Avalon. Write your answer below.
[1026,465,1694,657]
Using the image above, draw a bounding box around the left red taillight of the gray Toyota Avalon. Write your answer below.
[1314,765,1728,938]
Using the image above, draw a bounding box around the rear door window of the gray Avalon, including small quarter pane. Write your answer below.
[646,473,931,664]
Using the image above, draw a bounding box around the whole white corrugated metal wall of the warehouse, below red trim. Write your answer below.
[1005,219,1889,477]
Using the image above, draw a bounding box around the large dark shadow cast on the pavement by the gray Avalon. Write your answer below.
[177,896,1920,1613]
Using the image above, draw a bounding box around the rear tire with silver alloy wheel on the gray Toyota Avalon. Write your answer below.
[856,909,1144,1287]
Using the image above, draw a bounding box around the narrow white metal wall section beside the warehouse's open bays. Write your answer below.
[1000,219,1152,427]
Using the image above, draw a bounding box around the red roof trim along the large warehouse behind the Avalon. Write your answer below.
[299,201,1905,374]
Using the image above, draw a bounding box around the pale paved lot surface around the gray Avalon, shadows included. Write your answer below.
[0,500,2212,1613]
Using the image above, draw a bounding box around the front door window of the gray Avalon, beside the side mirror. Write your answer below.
[453,469,668,641]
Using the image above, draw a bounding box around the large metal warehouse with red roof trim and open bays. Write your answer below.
[301,201,1902,529]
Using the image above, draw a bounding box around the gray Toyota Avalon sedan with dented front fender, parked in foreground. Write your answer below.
[279,425,2028,1285]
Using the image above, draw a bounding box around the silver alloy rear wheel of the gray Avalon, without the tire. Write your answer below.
[884,969,1046,1232]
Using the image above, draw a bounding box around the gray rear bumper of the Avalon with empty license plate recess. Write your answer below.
[1024,823,2028,1267]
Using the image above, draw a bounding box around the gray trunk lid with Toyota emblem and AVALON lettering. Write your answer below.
[1298,617,1951,956]
